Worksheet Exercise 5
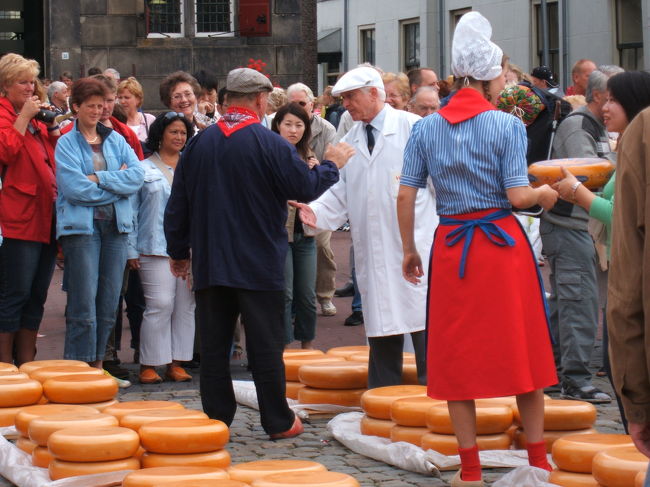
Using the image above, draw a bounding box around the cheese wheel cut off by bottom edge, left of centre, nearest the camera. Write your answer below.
[122,467,228,487]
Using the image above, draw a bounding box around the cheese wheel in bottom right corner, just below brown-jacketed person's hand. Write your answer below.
[592,446,648,487]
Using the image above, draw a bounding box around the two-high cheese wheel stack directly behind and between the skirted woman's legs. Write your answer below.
[421,399,513,455]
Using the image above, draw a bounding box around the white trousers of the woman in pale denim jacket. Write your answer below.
[140,255,195,365]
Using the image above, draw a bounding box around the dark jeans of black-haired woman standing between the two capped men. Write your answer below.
[284,233,316,344]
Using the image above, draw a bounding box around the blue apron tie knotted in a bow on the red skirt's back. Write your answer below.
[440,209,515,279]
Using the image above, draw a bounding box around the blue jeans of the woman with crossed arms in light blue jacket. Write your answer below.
[60,220,127,362]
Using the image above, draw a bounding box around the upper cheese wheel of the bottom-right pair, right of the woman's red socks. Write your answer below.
[552,433,634,473]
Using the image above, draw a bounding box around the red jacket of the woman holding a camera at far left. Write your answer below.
[0,96,58,243]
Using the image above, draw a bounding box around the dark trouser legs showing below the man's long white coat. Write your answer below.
[368,330,427,389]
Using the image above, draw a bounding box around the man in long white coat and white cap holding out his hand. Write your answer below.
[296,67,438,388]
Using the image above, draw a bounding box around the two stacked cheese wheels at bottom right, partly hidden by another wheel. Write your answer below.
[549,433,634,487]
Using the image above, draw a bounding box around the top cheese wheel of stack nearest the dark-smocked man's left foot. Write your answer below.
[139,418,229,454]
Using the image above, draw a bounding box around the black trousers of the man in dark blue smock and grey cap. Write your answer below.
[195,286,294,434]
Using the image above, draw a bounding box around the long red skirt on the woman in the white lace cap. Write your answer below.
[427,209,558,401]
